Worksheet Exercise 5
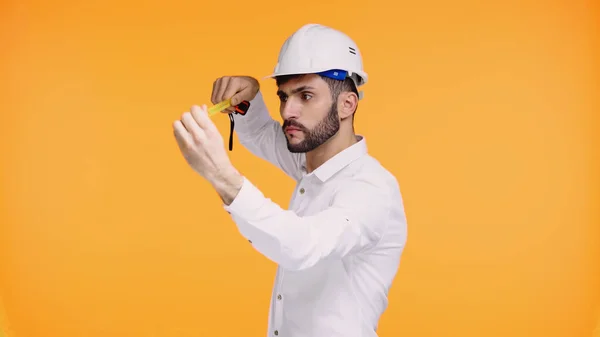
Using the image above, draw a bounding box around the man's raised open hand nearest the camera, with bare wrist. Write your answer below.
[173,105,243,197]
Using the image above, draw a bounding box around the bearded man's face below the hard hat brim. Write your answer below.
[277,75,340,153]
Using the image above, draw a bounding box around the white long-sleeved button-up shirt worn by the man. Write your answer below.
[224,92,407,337]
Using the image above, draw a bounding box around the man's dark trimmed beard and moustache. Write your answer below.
[282,103,340,153]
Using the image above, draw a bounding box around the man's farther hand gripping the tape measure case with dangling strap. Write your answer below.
[210,76,260,113]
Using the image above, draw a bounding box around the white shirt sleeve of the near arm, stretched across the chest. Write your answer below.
[224,178,391,270]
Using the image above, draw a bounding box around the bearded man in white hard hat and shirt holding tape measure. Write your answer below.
[174,24,406,337]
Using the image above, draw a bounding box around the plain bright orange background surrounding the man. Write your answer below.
[0,0,600,337]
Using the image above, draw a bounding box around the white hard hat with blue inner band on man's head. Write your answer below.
[266,23,368,98]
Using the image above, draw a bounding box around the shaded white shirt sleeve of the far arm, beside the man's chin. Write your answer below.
[233,91,304,180]
